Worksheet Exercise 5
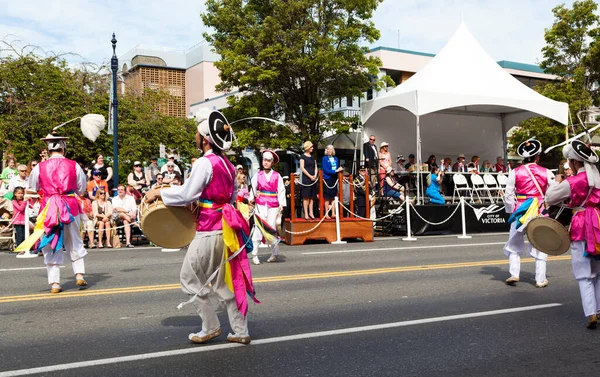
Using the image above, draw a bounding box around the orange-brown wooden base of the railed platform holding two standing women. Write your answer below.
[284,218,373,245]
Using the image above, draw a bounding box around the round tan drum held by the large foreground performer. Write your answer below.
[140,199,196,249]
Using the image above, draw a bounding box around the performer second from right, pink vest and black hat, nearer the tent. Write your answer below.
[504,140,554,288]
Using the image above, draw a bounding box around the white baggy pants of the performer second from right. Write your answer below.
[504,221,548,284]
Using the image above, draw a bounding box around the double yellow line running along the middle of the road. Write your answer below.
[0,255,571,303]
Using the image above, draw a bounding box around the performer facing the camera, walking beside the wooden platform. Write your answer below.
[248,149,286,265]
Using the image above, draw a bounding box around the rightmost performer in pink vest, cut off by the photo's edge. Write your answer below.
[546,140,600,329]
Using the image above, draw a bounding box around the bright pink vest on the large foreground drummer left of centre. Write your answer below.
[196,153,235,232]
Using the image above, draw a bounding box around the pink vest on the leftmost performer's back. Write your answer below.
[39,158,81,216]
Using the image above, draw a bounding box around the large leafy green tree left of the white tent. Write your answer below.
[201,0,391,146]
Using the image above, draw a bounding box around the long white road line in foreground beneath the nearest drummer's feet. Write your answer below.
[0,303,562,377]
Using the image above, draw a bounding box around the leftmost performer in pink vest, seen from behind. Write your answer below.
[15,134,87,293]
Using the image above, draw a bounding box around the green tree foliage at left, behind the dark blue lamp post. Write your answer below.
[0,44,197,181]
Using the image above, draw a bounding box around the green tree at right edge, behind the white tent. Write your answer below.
[511,0,600,148]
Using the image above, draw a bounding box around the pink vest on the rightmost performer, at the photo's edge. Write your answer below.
[567,172,600,241]
